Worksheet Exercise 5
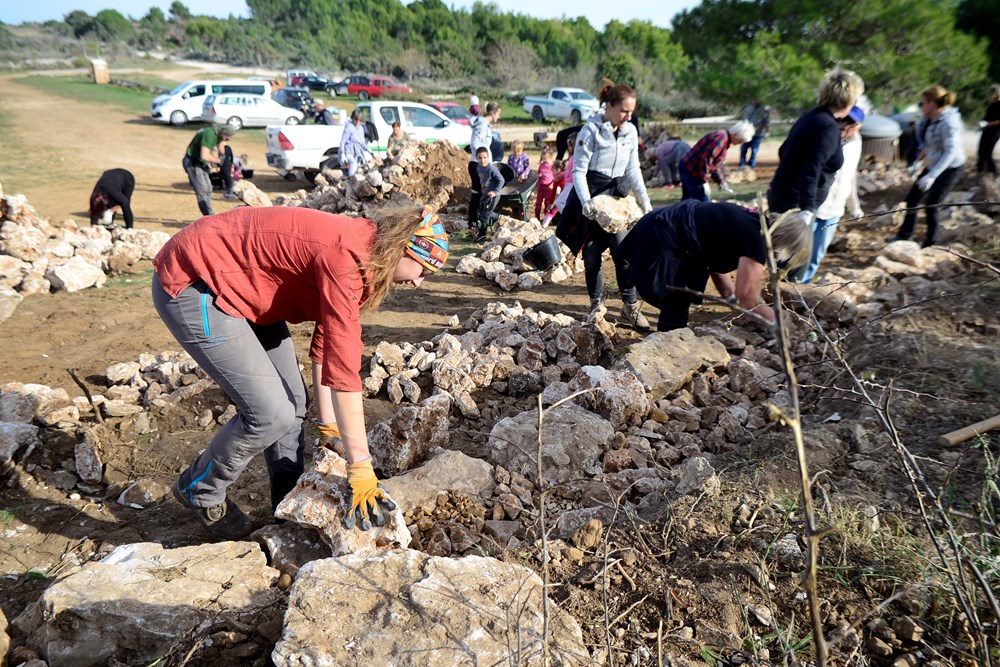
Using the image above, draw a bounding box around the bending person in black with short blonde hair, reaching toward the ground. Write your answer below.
[615,199,812,331]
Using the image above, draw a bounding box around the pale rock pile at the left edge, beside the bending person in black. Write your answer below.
[0,188,170,321]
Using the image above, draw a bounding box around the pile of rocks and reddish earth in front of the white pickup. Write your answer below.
[275,142,469,214]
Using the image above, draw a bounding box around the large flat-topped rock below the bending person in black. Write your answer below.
[613,329,729,401]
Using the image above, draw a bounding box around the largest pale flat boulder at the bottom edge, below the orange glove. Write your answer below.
[271,550,590,667]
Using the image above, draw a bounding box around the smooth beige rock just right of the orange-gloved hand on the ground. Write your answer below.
[383,449,496,511]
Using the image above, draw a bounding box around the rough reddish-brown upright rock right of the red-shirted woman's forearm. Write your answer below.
[368,394,450,477]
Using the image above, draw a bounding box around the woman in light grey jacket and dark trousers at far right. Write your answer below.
[886,86,966,248]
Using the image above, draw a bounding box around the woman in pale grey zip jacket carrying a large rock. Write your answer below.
[556,79,652,331]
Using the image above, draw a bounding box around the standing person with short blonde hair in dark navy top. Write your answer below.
[767,67,865,228]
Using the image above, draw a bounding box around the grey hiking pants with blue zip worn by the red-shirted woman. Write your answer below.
[153,273,308,507]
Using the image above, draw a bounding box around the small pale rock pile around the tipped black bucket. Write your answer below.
[455,216,583,292]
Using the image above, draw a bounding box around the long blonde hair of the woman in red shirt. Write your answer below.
[361,206,423,311]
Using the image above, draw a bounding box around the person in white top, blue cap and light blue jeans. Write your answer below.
[793,106,865,283]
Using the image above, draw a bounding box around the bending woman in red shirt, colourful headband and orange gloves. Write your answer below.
[152,206,448,540]
